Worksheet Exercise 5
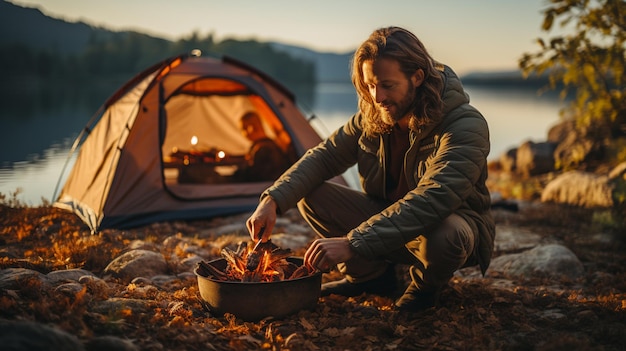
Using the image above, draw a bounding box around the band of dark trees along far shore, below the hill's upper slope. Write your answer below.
[0,32,316,93]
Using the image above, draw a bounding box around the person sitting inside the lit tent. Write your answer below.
[235,112,289,181]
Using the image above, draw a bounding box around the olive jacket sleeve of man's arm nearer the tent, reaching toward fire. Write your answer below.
[261,115,361,213]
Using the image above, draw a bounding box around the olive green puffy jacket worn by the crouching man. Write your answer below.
[263,67,495,274]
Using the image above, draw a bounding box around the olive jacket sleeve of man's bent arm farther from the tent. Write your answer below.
[348,105,489,258]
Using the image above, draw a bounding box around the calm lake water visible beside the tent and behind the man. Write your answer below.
[0,84,562,206]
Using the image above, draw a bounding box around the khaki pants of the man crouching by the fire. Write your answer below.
[298,182,476,291]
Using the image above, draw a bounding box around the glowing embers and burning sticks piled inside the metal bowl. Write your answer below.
[198,240,315,282]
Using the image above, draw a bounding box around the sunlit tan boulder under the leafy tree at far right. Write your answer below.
[541,171,613,208]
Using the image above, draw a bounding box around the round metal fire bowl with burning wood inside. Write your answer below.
[194,241,322,321]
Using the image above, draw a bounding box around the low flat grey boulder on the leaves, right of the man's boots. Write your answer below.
[487,244,584,279]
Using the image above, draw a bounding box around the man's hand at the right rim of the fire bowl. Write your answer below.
[304,237,355,272]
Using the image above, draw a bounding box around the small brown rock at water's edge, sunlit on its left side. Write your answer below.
[515,141,556,177]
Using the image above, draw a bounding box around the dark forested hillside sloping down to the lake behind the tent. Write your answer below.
[0,1,316,105]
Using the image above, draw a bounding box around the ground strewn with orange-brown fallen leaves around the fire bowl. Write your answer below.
[0,197,626,350]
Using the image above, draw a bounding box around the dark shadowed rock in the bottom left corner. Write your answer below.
[0,320,85,351]
